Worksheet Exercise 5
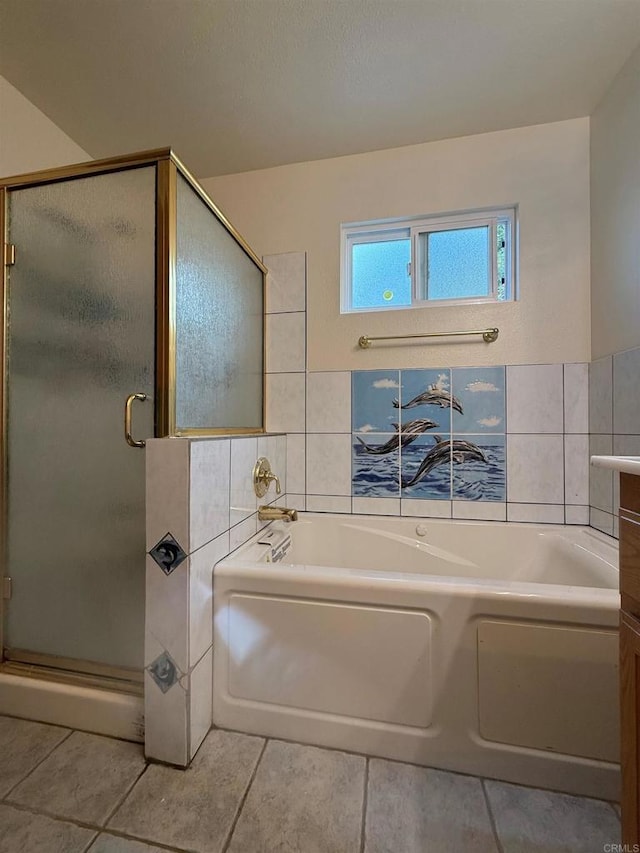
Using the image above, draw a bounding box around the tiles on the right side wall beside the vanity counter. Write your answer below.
[589,348,640,537]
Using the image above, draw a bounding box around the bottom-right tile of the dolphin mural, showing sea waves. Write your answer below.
[452,433,506,501]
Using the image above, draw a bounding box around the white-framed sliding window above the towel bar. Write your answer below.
[341,208,515,313]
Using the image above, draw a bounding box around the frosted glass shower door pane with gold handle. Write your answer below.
[4,166,156,669]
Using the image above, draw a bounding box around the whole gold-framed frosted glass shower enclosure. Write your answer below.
[0,149,266,732]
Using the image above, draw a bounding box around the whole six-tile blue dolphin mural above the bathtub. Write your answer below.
[352,366,506,501]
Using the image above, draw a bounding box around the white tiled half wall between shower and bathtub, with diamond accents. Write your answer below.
[144,435,287,766]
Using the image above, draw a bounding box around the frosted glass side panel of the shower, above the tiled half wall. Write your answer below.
[176,176,263,431]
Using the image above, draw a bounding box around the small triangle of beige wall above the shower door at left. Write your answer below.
[0,77,91,178]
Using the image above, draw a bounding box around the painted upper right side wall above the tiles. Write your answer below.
[591,47,640,358]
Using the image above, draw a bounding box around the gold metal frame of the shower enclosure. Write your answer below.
[0,148,267,680]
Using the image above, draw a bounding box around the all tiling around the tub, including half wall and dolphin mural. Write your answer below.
[145,246,608,766]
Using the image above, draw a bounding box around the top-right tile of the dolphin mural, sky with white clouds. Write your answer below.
[451,367,505,433]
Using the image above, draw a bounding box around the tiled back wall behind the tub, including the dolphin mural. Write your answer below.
[264,253,589,524]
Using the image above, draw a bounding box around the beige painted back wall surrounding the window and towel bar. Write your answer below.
[203,118,590,370]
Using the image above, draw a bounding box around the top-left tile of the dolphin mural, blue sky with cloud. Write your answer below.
[351,370,400,433]
